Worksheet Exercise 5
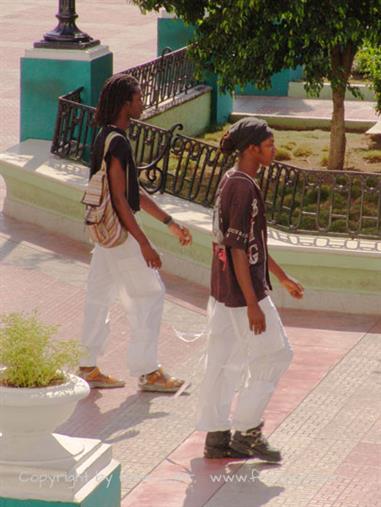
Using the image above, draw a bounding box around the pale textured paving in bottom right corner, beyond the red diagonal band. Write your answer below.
[205,333,381,507]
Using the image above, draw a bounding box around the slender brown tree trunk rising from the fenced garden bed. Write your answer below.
[328,43,357,171]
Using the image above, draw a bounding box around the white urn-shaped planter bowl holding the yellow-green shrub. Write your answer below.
[0,375,90,463]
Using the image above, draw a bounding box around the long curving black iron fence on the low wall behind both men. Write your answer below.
[52,90,381,239]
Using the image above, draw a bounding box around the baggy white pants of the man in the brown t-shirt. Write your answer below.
[197,297,293,431]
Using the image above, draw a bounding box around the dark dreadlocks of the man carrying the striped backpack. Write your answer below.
[94,74,140,127]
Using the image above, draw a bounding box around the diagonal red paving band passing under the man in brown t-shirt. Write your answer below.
[122,311,379,507]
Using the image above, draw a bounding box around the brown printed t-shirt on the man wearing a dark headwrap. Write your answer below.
[211,168,272,307]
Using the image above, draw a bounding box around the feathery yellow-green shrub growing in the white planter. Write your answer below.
[0,313,82,387]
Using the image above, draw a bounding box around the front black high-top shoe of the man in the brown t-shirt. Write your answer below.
[230,422,282,463]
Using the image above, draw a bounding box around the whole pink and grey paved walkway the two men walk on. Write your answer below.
[0,178,381,507]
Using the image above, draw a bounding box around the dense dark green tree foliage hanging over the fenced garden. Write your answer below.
[134,0,381,171]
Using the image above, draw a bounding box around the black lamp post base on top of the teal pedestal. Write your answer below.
[34,0,100,49]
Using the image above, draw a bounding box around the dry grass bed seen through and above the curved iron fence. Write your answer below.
[166,130,381,235]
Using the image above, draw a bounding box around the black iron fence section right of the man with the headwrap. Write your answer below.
[258,162,381,238]
